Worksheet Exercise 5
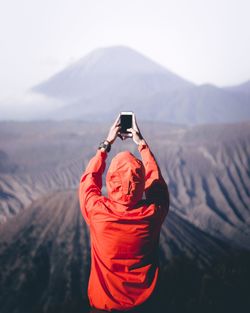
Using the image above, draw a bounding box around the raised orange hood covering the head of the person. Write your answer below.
[106,151,145,207]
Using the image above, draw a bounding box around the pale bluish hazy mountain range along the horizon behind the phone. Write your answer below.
[29,46,250,125]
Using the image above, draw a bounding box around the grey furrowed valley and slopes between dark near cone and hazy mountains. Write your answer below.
[0,121,250,247]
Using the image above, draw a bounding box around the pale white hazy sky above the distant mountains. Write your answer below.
[0,0,250,102]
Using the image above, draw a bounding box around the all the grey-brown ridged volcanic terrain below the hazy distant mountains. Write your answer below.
[0,119,250,313]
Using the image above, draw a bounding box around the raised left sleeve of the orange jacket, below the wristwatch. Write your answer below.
[78,150,107,224]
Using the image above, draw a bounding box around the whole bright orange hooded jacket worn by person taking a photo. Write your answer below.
[79,145,169,311]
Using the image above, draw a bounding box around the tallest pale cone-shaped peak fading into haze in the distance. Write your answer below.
[33,46,192,101]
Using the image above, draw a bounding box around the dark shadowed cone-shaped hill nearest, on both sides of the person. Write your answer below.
[0,190,250,313]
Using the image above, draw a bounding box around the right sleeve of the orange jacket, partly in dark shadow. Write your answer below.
[138,144,169,215]
